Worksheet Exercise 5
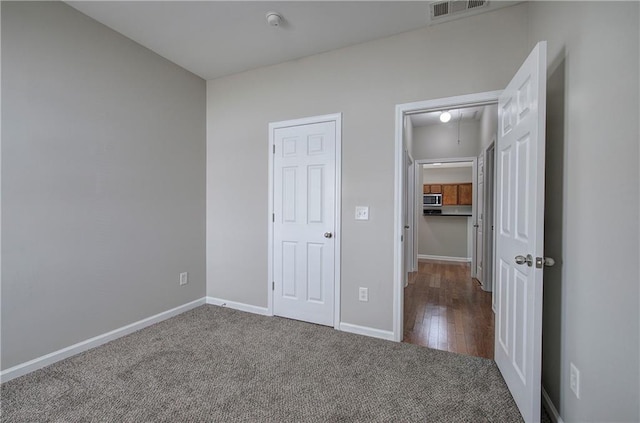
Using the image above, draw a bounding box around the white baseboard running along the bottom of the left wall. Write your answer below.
[0,298,205,383]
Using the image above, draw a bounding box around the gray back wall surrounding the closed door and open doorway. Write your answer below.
[207,5,528,331]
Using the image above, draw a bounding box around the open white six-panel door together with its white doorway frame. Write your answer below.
[393,41,553,421]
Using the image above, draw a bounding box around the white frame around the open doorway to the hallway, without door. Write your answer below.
[393,91,502,342]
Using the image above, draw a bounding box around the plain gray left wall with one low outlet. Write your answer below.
[2,2,206,369]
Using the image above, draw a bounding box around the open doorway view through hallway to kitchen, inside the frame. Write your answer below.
[402,102,497,359]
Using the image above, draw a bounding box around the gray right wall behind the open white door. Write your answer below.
[529,2,640,422]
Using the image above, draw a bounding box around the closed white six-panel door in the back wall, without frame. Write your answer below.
[272,121,336,326]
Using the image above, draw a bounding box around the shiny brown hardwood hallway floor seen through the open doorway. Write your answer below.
[403,260,494,359]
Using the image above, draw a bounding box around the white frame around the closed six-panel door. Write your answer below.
[267,113,342,329]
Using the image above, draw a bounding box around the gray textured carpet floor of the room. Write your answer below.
[0,305,536,422]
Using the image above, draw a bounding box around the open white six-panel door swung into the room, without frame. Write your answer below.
[494,41,547,422]
